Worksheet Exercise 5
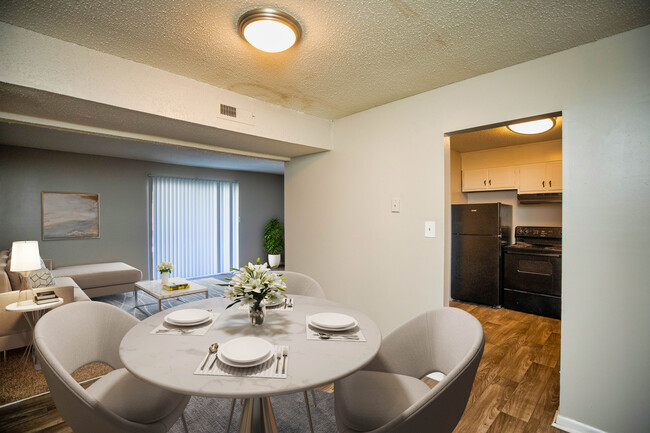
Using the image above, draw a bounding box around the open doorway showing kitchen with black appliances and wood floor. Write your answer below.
[444,112,562,431]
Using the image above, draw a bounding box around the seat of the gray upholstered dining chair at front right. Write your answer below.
[334,370,430,431]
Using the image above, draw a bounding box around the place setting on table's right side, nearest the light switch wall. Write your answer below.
[305,312,366,341]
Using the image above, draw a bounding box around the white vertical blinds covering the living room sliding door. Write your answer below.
[150,176,239,278]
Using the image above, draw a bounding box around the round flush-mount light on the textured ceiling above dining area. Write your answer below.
[237,8,302,53]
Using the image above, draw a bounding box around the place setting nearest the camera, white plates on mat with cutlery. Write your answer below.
[194,337,289,379]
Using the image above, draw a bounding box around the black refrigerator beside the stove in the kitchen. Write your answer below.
[451,203,512,307]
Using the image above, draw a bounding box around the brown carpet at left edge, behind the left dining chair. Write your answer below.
[0,348,112,406]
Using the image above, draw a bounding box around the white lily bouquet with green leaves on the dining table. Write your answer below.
[221,258,287,309]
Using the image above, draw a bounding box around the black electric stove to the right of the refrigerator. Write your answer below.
[503,226,562,319]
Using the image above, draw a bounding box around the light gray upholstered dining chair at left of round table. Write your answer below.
[34,301,190,433]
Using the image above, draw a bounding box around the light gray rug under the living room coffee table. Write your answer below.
[93,277,226,320]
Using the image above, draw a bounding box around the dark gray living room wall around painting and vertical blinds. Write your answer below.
[0,145,284,277]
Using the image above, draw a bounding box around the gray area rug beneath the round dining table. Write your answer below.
[170,391,337,433]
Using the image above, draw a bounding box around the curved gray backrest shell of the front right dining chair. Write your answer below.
[335,308,485,433]
